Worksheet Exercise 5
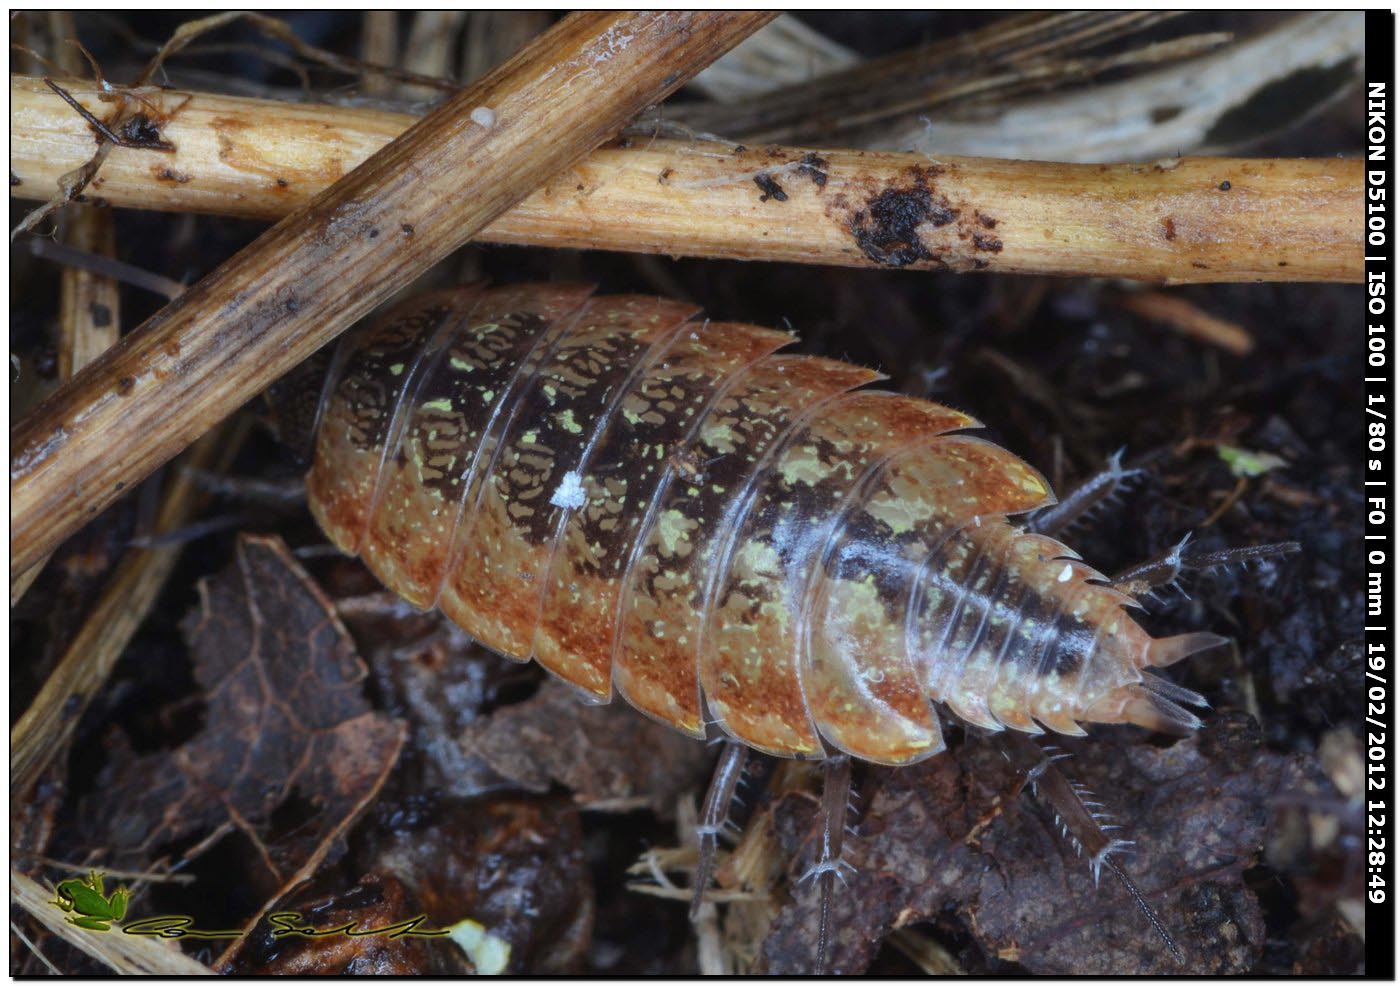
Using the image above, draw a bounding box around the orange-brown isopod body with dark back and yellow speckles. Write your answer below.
[308,284,1215,765]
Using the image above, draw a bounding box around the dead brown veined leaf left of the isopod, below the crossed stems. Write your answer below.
[81,536,405,957]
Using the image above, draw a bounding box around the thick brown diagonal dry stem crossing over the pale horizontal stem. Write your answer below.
[10,11,773,573]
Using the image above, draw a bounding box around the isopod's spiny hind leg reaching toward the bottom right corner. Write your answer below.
[1004,734,1186,965]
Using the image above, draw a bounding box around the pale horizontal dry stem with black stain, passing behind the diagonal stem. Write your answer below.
[11,78,1364,283]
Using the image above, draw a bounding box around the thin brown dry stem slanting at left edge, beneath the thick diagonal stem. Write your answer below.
[10,423,246,797]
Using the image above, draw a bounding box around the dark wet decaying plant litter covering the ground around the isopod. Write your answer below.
[11,14,1365,973]
